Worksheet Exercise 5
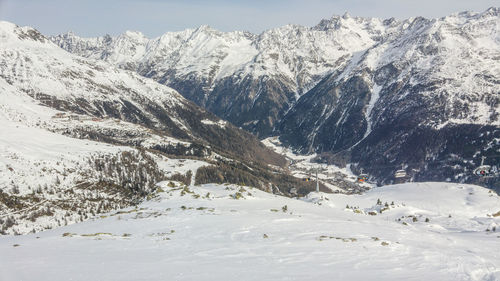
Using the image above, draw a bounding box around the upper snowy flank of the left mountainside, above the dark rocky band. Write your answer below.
[0,22,187,128]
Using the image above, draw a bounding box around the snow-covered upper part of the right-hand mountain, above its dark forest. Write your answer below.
[337,8,500,130]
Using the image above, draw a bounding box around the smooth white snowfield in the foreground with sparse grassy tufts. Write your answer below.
[0,180,500,281]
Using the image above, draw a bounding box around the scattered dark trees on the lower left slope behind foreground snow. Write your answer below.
[0,150,169,234]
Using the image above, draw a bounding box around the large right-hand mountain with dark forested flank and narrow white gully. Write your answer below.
[277,8,500,184]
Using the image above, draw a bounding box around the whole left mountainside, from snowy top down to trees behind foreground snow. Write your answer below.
[0,22,338,233]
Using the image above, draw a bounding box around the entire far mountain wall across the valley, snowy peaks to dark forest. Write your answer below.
[51,8,500,185]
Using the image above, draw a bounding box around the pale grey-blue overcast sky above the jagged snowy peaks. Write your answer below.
[0,0,500,37]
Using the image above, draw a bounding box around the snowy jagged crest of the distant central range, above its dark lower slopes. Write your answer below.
[50,7,498,92]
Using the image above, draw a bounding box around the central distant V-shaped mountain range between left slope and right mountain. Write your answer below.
[51,13,386,136]
